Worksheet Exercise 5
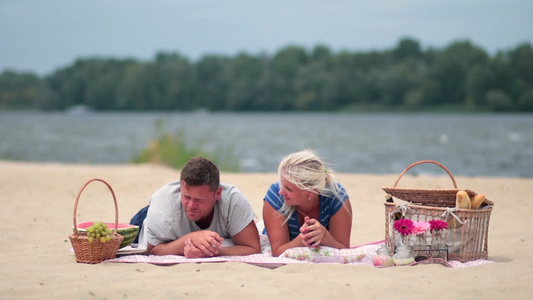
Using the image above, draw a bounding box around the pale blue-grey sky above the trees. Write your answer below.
[0,0,533,75]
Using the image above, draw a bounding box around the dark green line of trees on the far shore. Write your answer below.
[0,38,533,112]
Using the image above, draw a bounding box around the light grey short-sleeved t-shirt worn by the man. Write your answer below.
[139,181,255,249]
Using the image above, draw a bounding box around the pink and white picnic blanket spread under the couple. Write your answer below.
[105,235,492,268]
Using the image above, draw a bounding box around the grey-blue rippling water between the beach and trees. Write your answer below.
[0,112,533,177]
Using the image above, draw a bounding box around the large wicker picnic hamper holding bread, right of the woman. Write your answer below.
[383,160,494,262]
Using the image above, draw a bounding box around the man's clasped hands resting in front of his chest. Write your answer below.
[183,230,224,258]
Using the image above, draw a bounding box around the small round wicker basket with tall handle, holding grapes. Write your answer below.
[69,178,124,264]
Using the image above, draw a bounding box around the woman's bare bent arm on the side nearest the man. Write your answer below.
[263,201,305,256]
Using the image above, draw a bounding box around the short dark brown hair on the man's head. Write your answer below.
[180,156,220,192]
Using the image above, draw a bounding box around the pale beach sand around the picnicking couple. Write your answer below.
[0,161,533,299]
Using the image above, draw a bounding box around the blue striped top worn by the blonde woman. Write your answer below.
[263,182,348,240]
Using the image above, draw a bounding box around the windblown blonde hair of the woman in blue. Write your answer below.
[278,149,342,221]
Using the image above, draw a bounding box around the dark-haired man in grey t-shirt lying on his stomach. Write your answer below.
[131,157,261,258]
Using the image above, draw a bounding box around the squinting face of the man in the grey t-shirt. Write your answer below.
[181,181,222,222]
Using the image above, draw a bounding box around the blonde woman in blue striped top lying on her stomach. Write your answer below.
[263,150,352,256]
